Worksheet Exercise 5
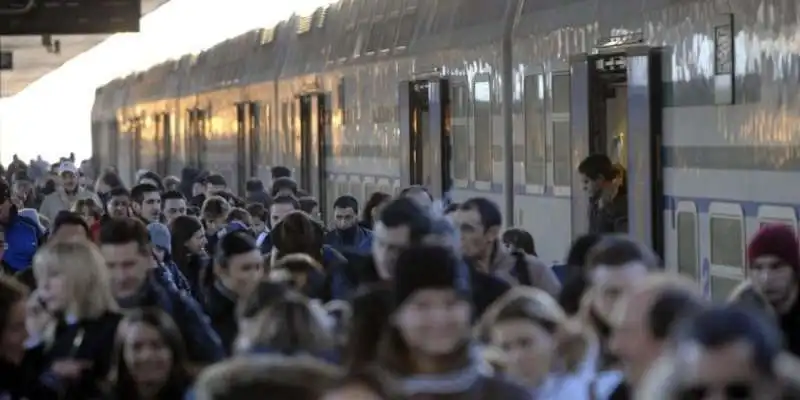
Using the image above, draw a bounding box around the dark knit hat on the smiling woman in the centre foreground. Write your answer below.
[394,246,469,307]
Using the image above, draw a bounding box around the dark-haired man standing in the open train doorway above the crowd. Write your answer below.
[578,154,628,234]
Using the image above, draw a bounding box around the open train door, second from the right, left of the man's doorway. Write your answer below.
[398,78,452,199]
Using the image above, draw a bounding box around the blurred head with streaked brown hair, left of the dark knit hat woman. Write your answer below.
[236,287,333,355]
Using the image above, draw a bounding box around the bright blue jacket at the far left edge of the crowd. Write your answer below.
[3,206,45,272]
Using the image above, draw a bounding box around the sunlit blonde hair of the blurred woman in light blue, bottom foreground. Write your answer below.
[475,286,594,372]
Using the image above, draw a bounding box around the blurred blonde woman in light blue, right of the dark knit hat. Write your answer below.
[476,286,599,400]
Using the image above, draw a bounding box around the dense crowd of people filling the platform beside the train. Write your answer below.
[0,152,800,400]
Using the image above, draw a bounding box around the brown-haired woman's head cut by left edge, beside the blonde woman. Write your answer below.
[0,275,28,364]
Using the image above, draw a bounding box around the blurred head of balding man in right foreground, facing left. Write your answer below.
[610,274,706,385]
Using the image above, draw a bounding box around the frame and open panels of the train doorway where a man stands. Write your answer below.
[570,45,665,256]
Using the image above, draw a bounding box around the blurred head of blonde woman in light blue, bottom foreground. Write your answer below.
[477,287,586,387]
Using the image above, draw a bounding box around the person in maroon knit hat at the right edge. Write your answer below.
[747,224,800,356]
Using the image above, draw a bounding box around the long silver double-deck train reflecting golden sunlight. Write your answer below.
[92,0,800,298]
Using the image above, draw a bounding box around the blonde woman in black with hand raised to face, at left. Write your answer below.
[31,241,122,399]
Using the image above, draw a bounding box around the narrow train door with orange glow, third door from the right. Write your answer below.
[297,93,328,221]
